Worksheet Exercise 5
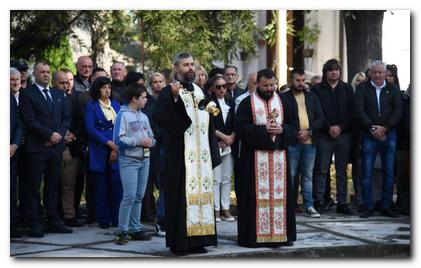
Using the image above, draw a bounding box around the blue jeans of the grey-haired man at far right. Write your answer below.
[361,131,397,209]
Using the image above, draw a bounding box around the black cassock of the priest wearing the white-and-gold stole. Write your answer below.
[155,84,221,251]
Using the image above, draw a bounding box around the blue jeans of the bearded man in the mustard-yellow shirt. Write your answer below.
[288,144,316,209]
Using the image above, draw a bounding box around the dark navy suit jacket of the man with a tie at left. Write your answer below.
[19,84,70,153]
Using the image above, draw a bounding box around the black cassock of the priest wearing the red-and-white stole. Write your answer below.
[235,93,298,247]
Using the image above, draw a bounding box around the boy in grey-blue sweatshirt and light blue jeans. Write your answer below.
[114,84,155,245]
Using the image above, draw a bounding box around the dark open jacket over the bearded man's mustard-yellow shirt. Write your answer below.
[281,89,323,141]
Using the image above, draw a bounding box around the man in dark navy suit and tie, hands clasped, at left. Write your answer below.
[19,61,72,237]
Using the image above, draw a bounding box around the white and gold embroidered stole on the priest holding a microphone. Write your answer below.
[179,84,215,236]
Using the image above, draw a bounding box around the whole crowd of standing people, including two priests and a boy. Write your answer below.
[10,52,410,255]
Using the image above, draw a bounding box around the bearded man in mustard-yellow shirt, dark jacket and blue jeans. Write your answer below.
[283,68,323,218]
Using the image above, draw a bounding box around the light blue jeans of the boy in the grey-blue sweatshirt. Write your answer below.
[117,156,149,233]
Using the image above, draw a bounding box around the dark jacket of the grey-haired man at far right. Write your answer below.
[355,81,402,132]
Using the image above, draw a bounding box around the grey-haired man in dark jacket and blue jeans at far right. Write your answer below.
[355,61,402,218]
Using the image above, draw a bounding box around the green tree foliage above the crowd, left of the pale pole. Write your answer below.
[10,10,258,71]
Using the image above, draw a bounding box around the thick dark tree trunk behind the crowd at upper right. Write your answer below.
[341,10,384,81]
